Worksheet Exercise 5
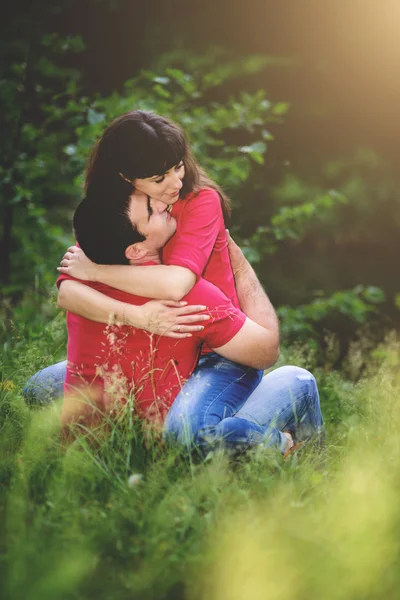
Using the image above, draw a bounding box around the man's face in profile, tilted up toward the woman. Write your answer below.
[129,193,176,252]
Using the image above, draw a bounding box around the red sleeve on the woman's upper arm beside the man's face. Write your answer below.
[167,188,224,277]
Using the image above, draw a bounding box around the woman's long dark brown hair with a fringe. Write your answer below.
[85,110,231,222]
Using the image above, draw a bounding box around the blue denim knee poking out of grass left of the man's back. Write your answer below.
[22,360,67,404]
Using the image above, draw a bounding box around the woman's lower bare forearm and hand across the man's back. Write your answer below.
[58,280,208,339]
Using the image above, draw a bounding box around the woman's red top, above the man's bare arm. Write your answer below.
[162,188,240,308]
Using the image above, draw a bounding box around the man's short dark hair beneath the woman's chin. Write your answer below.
[73,198,146,265]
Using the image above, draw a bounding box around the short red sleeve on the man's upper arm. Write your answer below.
[185,278,246,348]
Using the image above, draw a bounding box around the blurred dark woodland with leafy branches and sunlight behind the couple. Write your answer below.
[0,0,400,368]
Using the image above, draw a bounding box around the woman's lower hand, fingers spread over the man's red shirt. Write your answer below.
[124,300,210,339]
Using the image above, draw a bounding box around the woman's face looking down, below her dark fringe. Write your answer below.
[133,161,185,205]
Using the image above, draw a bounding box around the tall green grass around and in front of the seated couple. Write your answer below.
[0,300,400,600]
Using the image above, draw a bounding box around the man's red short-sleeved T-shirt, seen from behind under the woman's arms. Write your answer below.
[57,267,246,421]
